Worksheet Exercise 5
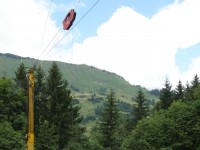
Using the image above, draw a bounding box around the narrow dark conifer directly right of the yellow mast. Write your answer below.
[34,66,53,150]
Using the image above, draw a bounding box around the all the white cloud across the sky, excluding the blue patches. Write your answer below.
[0,0,200,88]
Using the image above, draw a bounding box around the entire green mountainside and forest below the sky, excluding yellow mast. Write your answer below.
[0,54,200,150]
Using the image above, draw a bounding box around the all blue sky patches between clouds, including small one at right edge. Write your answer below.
[52,0,197,72]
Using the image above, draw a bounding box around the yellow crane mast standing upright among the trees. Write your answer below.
[26,68,35,150]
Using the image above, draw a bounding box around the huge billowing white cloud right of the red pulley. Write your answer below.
[66,0,200,88]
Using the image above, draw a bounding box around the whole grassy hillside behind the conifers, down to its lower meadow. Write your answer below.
[0,53,158,122]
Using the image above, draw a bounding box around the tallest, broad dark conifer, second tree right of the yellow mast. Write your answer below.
[47,62,84,149]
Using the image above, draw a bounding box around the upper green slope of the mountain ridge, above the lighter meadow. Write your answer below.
[0,53,157,102]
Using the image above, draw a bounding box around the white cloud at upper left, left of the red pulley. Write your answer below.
[0,0,72,59]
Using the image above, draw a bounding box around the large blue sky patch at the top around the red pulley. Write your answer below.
[52,0,177,40]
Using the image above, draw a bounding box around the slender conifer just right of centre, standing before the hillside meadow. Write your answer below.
[100,91,119,150]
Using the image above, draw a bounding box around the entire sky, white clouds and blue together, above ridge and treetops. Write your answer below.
[0,0,200,89]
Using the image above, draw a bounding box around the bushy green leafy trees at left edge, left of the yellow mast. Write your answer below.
[0,78,26,150]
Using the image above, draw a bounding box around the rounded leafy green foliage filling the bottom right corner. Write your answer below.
[123,98,200,150]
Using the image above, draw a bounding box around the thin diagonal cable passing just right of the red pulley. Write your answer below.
[45,0,100,56]
